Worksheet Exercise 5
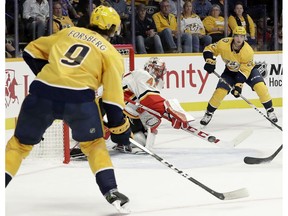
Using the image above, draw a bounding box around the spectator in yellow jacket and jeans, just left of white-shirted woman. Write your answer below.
[152,0,192,53]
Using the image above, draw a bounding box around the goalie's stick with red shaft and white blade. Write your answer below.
[125,97,252,148]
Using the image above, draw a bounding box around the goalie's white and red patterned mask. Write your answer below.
[144,57,167,80]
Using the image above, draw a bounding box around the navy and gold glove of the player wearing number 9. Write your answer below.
[109,118,131,145]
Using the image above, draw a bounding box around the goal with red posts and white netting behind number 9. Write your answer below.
[27,44,135,164]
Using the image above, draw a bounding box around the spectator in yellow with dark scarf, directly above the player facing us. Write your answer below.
[228,2,256,49]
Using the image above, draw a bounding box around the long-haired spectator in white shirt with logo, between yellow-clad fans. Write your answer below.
[181,0,212,52]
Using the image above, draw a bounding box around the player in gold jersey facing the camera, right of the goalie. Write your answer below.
[200,26,278,126]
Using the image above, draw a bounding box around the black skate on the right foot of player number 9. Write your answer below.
[105,189,131,214]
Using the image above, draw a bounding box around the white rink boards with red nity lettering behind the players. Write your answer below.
[5,53,283,118]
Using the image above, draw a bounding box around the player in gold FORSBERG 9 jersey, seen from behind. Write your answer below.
[5,6,131,212]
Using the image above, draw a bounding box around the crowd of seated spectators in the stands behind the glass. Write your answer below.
[6,0,282,57]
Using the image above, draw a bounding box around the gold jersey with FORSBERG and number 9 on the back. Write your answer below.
[25,27,124,107]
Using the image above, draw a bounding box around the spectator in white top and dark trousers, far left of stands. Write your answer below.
[23,0,49,40]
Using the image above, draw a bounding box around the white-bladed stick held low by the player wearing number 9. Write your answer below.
[130,138,249,200]
